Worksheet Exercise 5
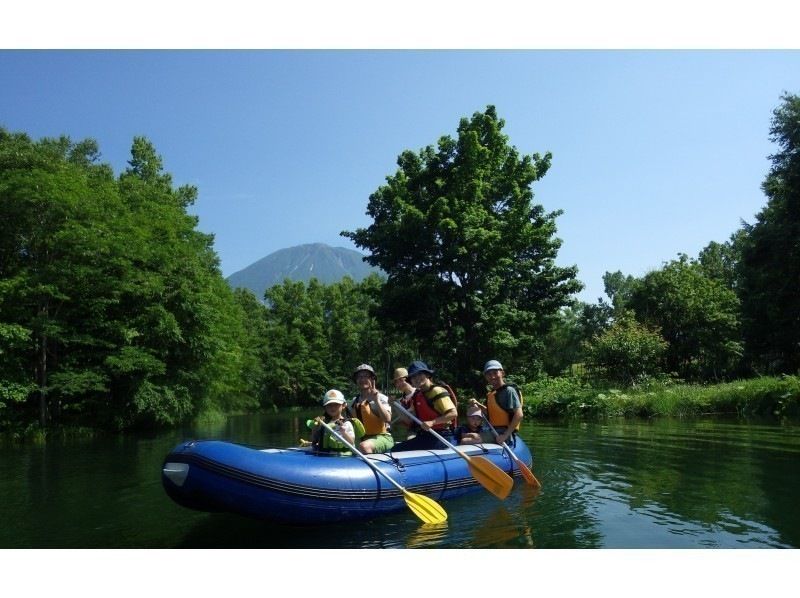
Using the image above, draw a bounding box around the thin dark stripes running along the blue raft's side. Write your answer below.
[167,453,522,501]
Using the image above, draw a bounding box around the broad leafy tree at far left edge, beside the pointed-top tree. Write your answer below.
[0,130,120,425]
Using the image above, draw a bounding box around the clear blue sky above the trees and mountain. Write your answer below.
[0,49,800,302]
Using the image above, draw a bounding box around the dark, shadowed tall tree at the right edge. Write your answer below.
[739,94,800,373]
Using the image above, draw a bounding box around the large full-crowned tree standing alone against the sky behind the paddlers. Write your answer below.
[342,106,582,392]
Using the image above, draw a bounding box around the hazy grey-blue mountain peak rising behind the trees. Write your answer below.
[227,243,381,299]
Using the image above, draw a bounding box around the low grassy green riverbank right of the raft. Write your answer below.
[522,376,800,419]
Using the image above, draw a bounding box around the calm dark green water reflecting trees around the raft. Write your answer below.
[0,412,800,548]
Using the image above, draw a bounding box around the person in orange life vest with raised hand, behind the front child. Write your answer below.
[349,363,394,453]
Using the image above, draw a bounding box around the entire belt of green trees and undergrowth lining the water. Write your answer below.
[0,95,800,430]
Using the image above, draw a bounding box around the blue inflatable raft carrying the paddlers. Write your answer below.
[162,438,532,525]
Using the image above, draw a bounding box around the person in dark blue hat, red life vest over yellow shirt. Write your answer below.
[392,361,458,452]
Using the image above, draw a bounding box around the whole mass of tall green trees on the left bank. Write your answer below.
[0,131,260,428]
